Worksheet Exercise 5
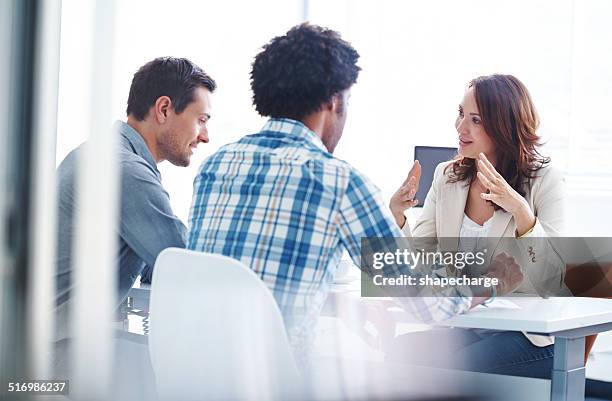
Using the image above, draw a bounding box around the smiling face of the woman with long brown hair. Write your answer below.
[455,87,496,163]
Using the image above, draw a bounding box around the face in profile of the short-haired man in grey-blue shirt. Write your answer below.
[157,87,211,167]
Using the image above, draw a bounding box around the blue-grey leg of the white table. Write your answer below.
[550,337,585,401]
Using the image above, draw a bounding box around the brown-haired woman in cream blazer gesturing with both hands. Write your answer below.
[390,75,568,377]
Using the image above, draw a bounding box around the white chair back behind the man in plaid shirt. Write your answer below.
[149,248,299,400]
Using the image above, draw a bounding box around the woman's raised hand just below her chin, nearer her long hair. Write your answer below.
[477,153,536,237]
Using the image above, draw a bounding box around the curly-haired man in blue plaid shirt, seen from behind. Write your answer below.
[187,23,520,361]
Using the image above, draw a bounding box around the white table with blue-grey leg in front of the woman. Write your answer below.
[442,297,612,401]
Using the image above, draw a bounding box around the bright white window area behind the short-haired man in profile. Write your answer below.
[57,0,303,221]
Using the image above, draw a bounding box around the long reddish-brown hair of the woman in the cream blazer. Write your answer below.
[446,74,550,210]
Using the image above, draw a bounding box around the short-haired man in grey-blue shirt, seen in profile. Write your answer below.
[56,57,216,338]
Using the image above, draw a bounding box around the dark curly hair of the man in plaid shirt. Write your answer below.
[251,23,360,120]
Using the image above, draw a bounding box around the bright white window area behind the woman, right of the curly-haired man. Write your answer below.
[309,0,612,195]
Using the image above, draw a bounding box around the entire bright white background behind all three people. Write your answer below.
[57,0,612,235]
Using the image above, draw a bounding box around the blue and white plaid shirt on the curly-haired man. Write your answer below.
[187,119,471,360]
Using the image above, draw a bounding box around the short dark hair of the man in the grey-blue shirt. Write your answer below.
[126,57,217,121]
